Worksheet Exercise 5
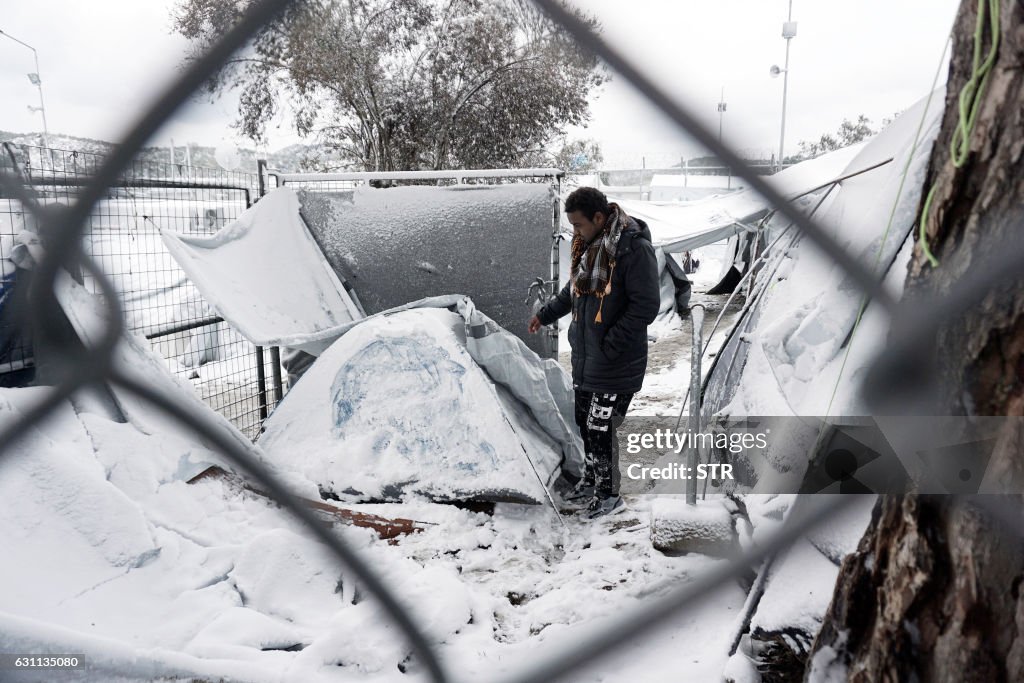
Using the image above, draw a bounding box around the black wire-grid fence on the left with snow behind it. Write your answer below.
[0,142,283,439]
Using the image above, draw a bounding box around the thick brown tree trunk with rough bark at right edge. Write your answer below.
[806,0,1024,681]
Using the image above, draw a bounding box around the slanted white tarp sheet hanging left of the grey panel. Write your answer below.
[160,187,360,354]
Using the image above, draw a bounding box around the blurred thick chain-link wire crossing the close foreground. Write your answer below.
[0,0,1024,683]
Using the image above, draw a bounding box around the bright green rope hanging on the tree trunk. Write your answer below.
[918,0,999,268]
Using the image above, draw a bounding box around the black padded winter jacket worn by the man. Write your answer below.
[537,217,660,393]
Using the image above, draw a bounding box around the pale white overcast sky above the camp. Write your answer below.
[0,0,958,167]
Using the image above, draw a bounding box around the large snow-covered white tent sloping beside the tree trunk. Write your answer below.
[702,90,942,492]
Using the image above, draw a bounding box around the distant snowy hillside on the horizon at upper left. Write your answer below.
[0,130,340,173]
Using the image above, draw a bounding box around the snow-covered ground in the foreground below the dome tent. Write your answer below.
[0,378,743,681]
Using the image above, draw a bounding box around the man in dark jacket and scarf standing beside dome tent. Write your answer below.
[527,187,660,519]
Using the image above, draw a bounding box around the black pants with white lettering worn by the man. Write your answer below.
[575,389,633,498]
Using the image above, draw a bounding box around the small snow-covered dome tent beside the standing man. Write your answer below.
[260,296,582,503]
